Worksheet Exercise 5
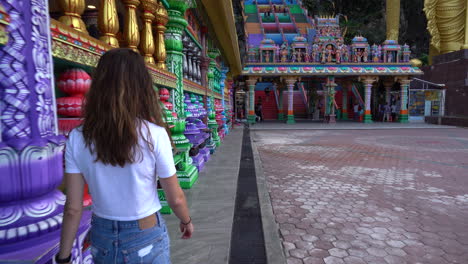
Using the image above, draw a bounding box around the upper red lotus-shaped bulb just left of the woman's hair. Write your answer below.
[57,69,91,97]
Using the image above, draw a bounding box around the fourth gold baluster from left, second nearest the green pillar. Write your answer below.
[140,0,157,64]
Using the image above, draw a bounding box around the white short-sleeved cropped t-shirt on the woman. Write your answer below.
[65,122,176,221]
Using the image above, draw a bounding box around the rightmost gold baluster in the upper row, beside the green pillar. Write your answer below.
[154,3,169,70]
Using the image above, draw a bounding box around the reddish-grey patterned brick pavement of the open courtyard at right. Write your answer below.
[253,129,468,264]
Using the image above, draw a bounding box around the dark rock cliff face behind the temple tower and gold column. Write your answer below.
[302,0,430,57]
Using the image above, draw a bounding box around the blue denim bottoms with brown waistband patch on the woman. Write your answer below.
[90,212,171,264]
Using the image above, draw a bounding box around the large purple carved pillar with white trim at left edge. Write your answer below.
[0,0,80,263]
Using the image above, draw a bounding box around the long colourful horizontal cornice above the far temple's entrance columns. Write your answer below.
[242,63,424,76]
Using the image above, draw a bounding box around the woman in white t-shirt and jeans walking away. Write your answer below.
[55,49,193,264]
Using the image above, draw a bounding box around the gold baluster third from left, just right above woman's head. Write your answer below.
[122,0,140,52]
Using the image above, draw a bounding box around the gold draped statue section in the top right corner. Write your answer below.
[424,0,468,55]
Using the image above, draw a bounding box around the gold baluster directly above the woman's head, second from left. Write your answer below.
[98,0,119,48]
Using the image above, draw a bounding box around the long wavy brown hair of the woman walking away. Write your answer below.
[82,49,167,167]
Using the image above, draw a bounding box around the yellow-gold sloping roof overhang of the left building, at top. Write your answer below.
[201,0,242,76]
